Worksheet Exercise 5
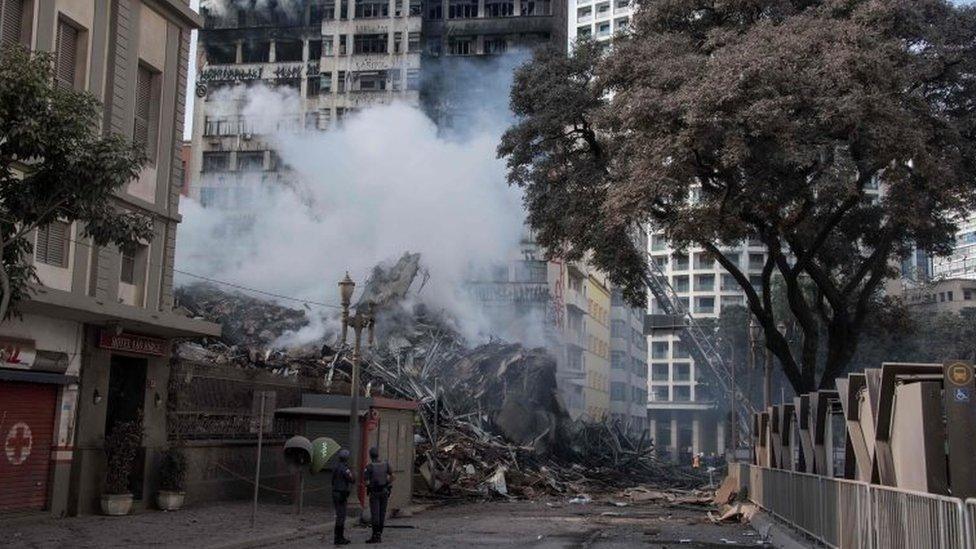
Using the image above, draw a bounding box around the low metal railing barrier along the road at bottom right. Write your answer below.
[731,463,976,549]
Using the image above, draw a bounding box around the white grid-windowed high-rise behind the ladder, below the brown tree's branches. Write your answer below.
[647,232,766,459]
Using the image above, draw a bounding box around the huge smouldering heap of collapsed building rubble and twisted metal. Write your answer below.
[178,254,704,501]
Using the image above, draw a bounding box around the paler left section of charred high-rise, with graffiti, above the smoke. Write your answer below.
[189,0,421,209]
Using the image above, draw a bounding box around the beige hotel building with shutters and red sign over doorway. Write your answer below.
[0,0,220,520]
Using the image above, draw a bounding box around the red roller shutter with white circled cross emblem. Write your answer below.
[0,381,57,511]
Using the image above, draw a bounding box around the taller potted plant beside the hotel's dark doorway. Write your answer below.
[102,421,142,516]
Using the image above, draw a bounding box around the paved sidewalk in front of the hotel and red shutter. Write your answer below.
[0,502,340,549]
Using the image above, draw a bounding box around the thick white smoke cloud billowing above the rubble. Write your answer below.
[177,56,544,346]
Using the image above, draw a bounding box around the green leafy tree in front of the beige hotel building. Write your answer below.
[0,46,152,320]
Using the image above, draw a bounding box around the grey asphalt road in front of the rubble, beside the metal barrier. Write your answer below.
[274,500,760,548]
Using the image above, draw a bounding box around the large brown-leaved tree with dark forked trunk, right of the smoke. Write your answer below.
[498,0,976,392]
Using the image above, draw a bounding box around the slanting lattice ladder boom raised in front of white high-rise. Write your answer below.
[645,259,756,445]
